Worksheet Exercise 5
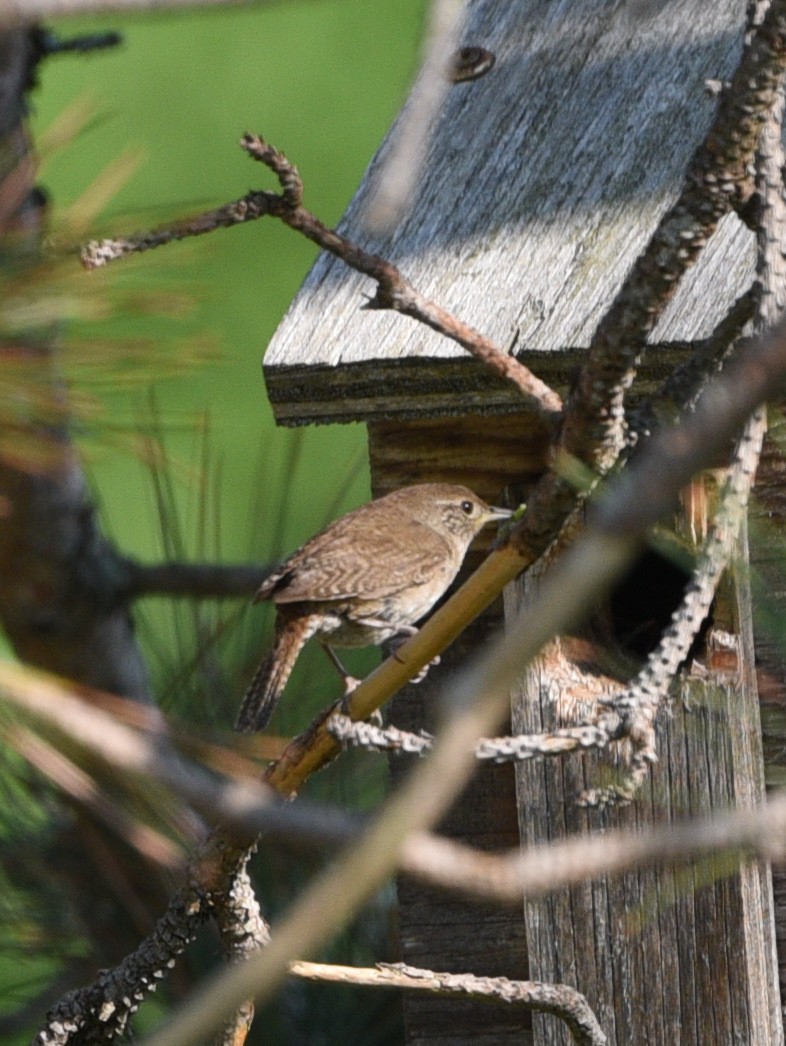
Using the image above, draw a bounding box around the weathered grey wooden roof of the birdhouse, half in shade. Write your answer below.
[264,0,754,425]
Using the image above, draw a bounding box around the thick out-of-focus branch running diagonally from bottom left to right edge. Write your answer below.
[137,307,786,1046]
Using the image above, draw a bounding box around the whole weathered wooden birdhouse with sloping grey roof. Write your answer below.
[264,0,786,1046]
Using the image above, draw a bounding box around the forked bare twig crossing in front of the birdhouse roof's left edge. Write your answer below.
[82,134,562,426]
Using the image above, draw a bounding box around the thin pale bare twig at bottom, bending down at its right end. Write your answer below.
[289,961,608,1046]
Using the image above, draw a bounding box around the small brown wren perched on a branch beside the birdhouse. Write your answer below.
[235,483,511,733]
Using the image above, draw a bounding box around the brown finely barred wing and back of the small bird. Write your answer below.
[261,507,453,602]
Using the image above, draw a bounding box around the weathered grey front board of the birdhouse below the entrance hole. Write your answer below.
[514,510,783,1046]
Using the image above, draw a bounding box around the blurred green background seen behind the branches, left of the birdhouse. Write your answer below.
[0,0,425,1044]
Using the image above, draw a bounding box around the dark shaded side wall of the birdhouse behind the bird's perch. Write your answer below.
[368,414,535,1046]
